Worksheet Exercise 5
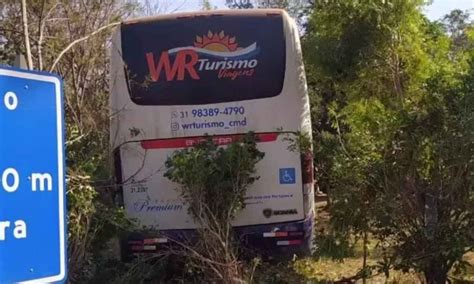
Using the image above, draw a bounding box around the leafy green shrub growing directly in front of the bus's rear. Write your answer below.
[165,133,264,283]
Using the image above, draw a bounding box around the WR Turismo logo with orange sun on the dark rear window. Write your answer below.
[146,31,259,82]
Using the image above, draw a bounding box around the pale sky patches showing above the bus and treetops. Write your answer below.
[162,0,474,20]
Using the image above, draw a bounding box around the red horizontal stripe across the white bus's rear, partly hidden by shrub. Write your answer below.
[141,133,278,150]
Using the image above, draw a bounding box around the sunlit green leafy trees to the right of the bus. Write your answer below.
[303,1,474,283]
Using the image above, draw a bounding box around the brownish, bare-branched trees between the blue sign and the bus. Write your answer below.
[0,0,138,283]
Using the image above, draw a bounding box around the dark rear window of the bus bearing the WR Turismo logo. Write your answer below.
[121,15,285,105]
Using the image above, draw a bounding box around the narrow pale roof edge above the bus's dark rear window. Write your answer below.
[122,9,287,25]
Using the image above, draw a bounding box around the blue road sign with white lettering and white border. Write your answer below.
[0,68,67,284]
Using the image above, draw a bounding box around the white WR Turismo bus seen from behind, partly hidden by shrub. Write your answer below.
[110,10,314,256]
